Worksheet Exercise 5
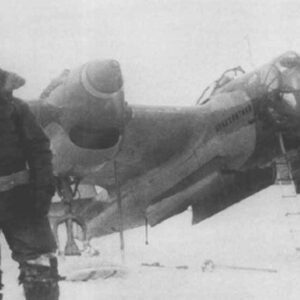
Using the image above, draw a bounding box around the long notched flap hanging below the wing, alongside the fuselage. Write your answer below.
[146,167,274,226]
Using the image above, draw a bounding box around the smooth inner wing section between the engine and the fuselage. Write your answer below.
[84,106,205,190]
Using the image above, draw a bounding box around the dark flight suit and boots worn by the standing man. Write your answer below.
[0,96,59,300]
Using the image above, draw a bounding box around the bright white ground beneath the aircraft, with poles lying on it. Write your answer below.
[2,186,300,300]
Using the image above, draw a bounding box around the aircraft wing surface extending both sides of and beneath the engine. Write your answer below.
[31,103,207,191]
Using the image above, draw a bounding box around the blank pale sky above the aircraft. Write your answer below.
[0,0,300,105]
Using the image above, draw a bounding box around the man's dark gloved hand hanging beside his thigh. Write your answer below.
[34,186,55,217]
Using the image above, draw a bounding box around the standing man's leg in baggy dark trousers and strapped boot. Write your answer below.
[2,217,60,300]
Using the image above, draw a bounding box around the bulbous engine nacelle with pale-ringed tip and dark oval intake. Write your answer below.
[42,60,130,149]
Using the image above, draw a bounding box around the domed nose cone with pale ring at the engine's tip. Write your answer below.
[81,60,123,99]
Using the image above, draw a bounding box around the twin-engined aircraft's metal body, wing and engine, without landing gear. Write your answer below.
[30,52,300,252]
